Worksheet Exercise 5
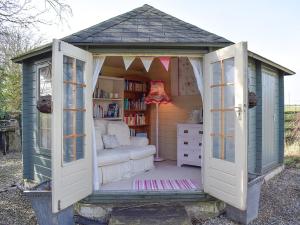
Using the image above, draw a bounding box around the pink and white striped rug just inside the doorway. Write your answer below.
[133,179,199,191]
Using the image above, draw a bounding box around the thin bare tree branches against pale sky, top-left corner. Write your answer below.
[0,0,72,30]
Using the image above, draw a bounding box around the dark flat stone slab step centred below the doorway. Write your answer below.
[109,205,191,225]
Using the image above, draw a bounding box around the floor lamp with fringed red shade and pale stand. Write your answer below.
[145,80,171,162]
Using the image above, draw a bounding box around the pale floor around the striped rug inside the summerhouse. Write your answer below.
[101,160,203,191]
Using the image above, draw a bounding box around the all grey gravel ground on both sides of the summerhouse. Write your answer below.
[0,152,300,225]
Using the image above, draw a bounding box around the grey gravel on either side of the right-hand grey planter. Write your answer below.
[203,168,300,225]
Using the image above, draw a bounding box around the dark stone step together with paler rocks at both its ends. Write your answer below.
[75,200,225,225]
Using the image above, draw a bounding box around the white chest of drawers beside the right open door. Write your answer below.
[177,123,203,167]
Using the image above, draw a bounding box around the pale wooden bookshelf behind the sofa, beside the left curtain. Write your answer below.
[93,76,124,120]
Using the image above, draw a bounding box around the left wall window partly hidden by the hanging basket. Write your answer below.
[37,63,52,150]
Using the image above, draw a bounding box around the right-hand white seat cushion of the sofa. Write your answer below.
[114,145,156,159]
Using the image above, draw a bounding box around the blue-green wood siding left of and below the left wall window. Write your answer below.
[22,58,51,182]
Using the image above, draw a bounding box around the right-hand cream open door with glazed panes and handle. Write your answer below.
[203,42,248,210]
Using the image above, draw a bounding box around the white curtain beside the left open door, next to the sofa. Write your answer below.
[92,56,105,190]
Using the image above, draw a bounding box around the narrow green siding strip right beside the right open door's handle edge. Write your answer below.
[247,58,256,173]
